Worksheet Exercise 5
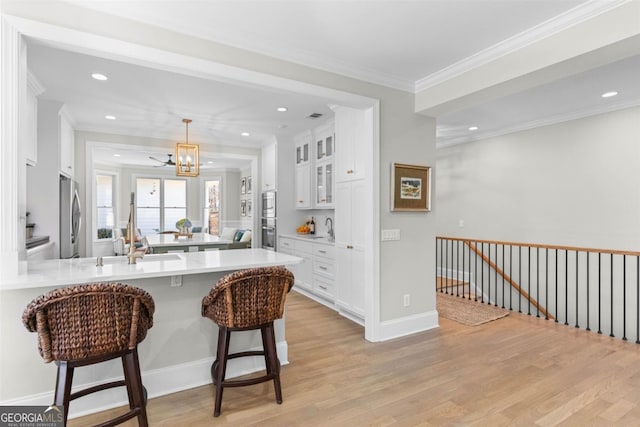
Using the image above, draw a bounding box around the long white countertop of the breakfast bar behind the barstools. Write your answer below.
[0,249,302,290]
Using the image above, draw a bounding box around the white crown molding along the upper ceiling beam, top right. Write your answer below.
[414,0,632,93]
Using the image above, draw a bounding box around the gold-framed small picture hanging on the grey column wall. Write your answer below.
[391,163,431,212]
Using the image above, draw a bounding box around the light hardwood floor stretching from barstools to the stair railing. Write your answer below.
[69,292,640,427]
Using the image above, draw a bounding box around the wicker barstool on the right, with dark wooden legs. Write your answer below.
[202,267,294,417]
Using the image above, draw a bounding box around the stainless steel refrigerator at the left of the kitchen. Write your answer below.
[60,175,82,258]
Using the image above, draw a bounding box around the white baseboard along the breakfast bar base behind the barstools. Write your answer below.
[0,341,289,418]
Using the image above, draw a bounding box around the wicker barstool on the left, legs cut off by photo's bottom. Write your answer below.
[22,283,155,427]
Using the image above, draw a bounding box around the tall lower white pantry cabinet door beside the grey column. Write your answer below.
[335,180,367,322]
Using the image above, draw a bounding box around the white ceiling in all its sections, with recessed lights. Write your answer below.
[22,0,640,165]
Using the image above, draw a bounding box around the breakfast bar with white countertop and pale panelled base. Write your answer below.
[0,249,302,417]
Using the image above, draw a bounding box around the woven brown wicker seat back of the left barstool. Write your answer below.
[22,283,155,362]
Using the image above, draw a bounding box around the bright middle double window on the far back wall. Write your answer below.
[136,178,187,235]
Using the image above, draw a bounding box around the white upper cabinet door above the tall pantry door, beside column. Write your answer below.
[334,106,372,182]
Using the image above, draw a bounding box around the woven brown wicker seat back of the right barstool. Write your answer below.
[202,267,294,328]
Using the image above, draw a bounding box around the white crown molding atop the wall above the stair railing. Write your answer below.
[436,100,640,148]
